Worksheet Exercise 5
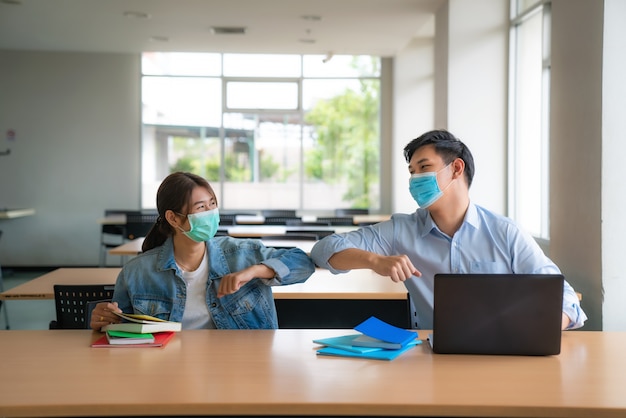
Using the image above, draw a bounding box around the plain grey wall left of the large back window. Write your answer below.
[0,51,140,267]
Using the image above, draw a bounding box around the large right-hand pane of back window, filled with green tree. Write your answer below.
[303,79,380,209]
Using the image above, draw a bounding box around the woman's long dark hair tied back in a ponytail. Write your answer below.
[141,171,217,252]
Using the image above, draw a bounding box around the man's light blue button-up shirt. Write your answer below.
[311,203,587,329]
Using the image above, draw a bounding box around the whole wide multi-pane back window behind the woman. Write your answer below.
[142,53,380,211]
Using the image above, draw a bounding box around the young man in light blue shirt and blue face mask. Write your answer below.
[311,130,587,329]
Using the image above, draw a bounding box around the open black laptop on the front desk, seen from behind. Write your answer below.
[429,274,564,356]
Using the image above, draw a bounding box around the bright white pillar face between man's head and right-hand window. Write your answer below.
[448,0,509,215]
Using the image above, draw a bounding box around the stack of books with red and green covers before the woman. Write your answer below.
[91,312,182,347]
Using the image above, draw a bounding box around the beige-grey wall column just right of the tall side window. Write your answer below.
[550,0,604,330]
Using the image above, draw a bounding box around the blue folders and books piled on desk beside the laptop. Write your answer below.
[313,317,422,360]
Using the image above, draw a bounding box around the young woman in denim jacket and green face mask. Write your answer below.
[90,172,315,329]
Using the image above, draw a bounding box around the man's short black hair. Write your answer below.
[404,129,474,187]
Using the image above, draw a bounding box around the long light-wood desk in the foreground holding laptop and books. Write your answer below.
[0,330,626,418]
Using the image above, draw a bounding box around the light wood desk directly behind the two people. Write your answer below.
[0,267,411,328]
